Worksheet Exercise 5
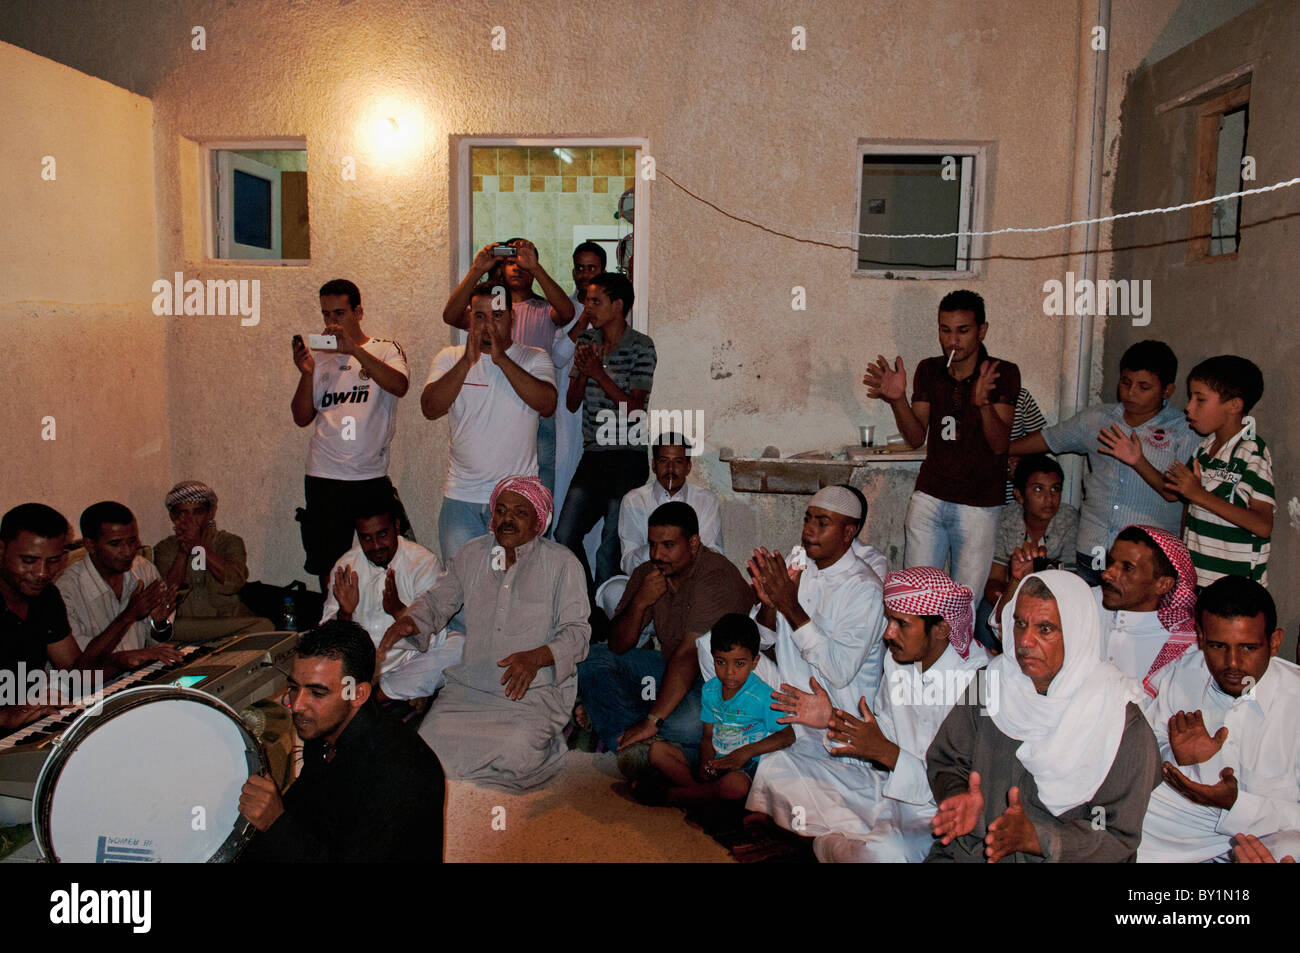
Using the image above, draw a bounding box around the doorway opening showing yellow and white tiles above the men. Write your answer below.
[452,138,649,332]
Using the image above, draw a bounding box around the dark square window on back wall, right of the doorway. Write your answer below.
[854,143,988,278]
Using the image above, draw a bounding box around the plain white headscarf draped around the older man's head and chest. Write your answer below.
[989,569,1144,816]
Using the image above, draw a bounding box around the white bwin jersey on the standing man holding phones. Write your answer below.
[307,338,411,480]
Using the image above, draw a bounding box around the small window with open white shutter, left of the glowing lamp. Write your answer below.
[207,140,311,263]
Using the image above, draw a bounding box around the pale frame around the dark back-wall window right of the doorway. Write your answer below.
[852,139,995,281]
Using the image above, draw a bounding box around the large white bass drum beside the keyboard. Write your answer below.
[31,685,265,863]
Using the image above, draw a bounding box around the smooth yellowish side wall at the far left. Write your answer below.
[0,43,172,543]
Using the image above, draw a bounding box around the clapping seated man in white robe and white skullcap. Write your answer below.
[691,486,885,836]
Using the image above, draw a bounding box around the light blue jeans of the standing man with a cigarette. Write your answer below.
[904,491,1002,593]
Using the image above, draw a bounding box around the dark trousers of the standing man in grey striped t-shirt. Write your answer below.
[555,447,650,599]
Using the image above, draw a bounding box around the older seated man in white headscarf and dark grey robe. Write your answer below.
[926,569,1160,863]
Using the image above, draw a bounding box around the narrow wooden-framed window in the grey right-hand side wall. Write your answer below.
[1187,75,1251,261]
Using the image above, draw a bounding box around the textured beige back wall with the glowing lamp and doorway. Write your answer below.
[0,0,1216,581]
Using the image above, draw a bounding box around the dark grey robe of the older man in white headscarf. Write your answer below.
[926,686,1161,863]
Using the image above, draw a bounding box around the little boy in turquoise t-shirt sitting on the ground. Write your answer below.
[632,612,794,805]
